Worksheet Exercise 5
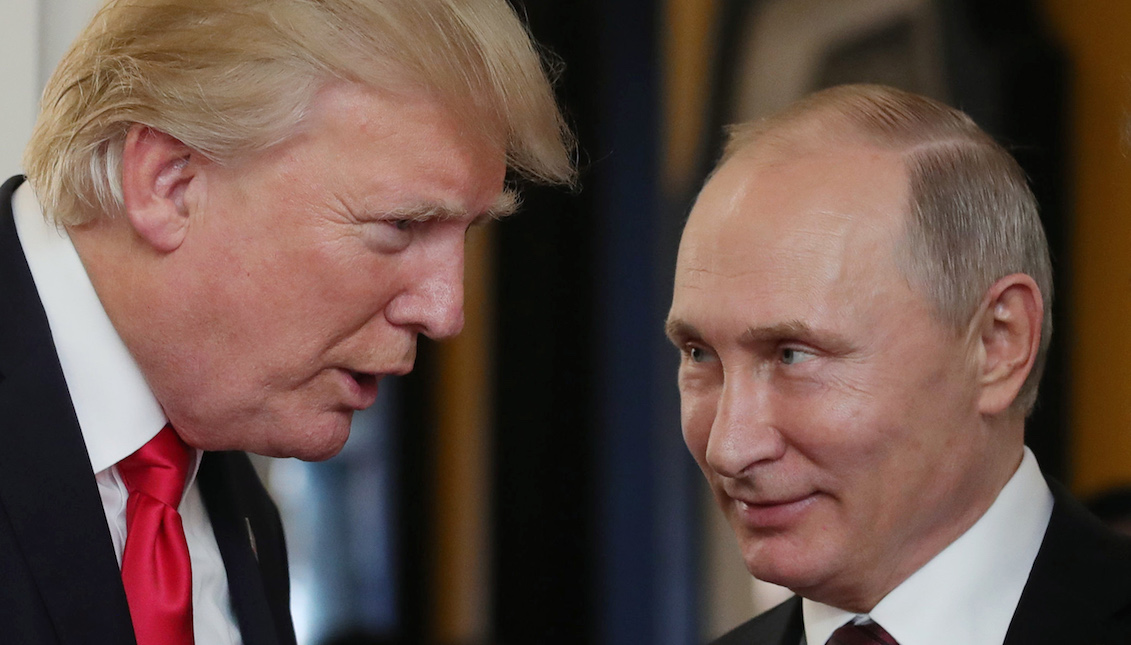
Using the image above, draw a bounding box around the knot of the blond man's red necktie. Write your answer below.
[118,425,192,510]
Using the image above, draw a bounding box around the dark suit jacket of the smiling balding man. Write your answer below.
[714,482,1131,645]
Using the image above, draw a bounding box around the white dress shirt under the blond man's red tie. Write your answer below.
[12,183,241,645]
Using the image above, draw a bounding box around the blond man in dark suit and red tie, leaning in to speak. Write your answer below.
[0,0,573,645]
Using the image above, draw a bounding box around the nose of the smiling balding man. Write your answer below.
[706,377,786,478]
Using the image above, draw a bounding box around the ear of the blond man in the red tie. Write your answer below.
[122,124,193,252]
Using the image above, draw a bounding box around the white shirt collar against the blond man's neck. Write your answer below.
[12,182,178,473]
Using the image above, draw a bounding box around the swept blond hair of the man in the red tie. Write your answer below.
[24,0,575,224]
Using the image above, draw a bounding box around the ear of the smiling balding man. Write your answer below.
[974,274,1044,414]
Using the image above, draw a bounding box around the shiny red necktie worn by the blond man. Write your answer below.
[118,425,193,645]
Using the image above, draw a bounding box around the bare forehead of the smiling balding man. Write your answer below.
[673,142,908,323]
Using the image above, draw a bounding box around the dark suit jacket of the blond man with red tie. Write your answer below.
[0,178,295,645]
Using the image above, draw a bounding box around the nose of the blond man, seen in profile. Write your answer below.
[386,235,464,341]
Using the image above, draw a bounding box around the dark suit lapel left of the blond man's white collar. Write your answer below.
[0,178,133,643]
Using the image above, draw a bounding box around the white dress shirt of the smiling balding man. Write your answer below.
[802,448,1053,645]
